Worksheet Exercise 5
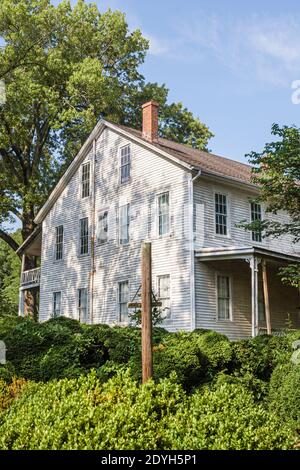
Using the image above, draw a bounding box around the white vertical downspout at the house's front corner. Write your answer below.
[189,170,201,331]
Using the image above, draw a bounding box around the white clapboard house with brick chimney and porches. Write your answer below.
[19,102,300,339]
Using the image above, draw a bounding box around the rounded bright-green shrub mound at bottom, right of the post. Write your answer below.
[165,384,295,450]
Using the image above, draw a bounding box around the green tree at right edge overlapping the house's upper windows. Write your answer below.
[245,124,300,287]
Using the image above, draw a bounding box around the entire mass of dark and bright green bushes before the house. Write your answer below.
[0,317,300,450]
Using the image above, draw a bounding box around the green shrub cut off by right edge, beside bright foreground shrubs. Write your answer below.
[269,362,300,429]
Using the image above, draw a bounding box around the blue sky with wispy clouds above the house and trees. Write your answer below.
[96,0,300,161]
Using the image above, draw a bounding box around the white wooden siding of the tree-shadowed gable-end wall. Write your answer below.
[40,129,191,330]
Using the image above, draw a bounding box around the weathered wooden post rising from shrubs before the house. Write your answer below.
[141,242,152,383]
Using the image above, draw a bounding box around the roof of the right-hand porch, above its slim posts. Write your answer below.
[195,246,300,263]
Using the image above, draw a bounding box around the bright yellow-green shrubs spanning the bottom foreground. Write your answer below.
[0,372,294,450]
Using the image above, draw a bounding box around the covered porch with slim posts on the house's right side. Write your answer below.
[195,246,300,338]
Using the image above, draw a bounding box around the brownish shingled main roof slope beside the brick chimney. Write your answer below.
[117,125,251,183]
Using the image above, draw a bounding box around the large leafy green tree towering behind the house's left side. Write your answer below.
[0,0,212,260]
